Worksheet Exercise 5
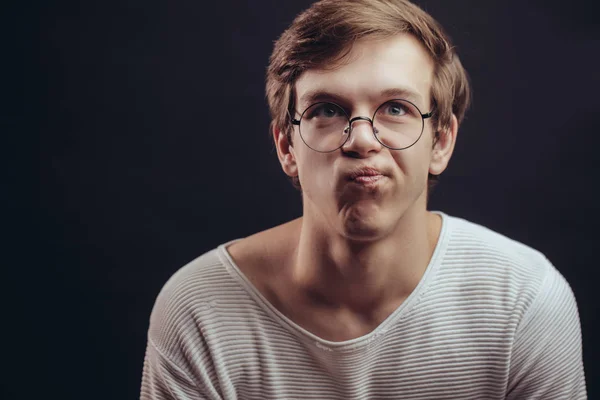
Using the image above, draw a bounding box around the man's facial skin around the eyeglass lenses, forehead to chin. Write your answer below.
[278,34,452,241]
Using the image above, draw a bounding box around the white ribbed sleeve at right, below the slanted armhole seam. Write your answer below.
[506,265,587,400]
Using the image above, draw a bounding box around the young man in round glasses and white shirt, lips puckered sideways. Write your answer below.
[141,0,586,400]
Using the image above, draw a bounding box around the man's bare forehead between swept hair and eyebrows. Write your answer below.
[295,34,433,112]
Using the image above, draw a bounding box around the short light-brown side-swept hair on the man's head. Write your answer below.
[266,0,471,188]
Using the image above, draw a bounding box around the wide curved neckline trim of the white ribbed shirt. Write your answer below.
[217,211,451,351]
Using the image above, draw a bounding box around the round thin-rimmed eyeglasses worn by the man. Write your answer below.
[292,99,433,153]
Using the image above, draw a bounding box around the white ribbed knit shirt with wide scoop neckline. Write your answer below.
[141,213,586,400]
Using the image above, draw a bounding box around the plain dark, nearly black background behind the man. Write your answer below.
[11,0,600,399]
